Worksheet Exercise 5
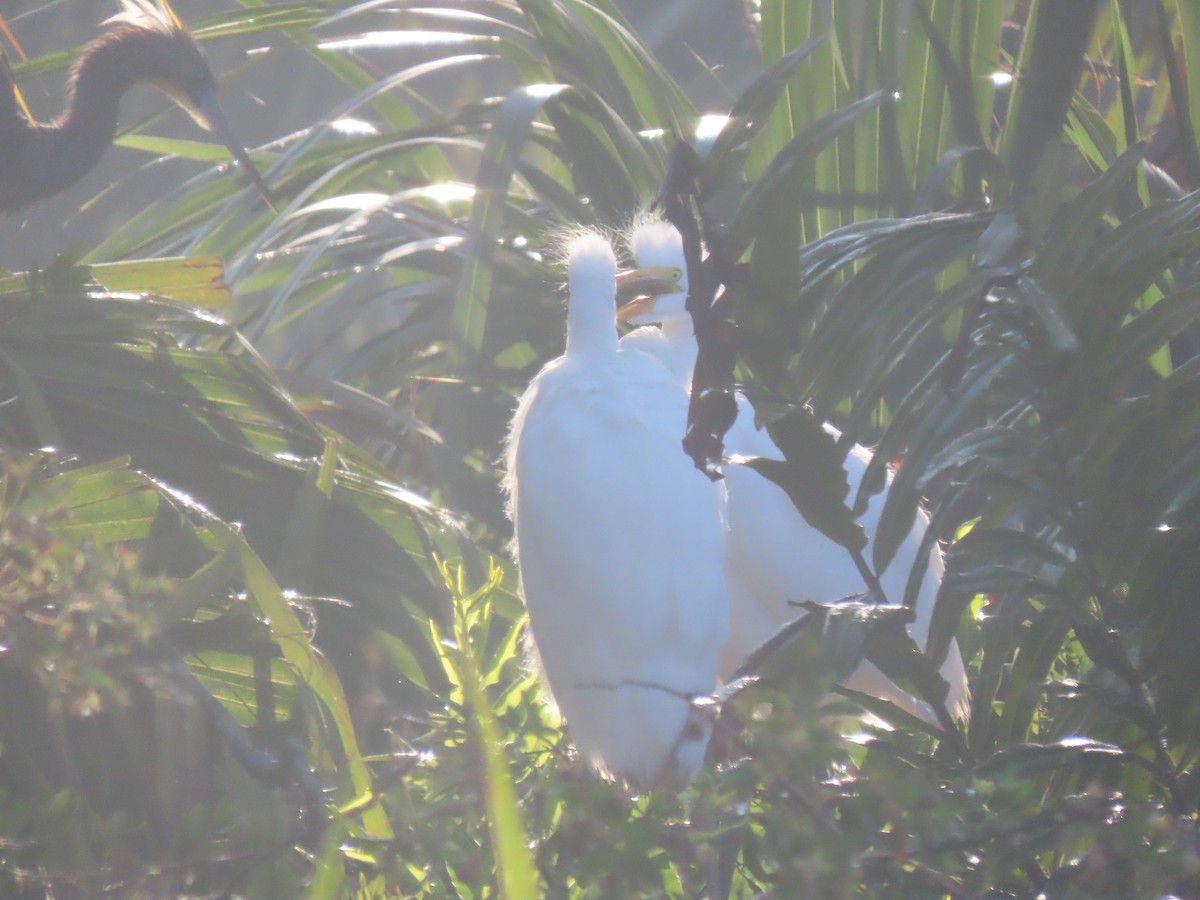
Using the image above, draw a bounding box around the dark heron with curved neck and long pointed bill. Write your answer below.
[0,0,271,210]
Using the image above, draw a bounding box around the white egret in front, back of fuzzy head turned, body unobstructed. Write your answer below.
[505,234,728,787]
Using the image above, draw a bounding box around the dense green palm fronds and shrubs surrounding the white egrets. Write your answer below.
[0,0,1200,899]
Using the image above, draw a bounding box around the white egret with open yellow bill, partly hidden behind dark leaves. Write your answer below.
[619,221,970,725]
